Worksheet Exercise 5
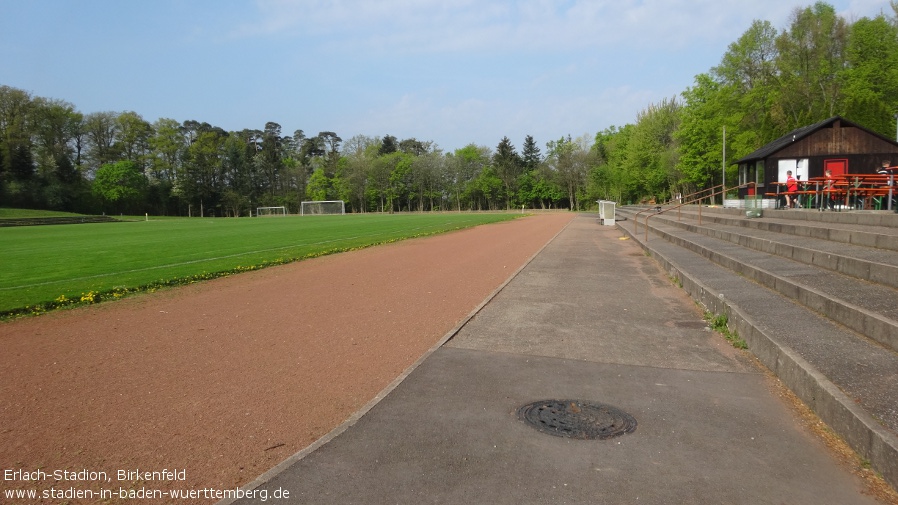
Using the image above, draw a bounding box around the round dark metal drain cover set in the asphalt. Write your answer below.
[518,400,636,440]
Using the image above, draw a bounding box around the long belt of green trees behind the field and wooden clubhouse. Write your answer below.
[0,1,898,216]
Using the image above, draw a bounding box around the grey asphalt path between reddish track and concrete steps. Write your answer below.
[228,215,877,505]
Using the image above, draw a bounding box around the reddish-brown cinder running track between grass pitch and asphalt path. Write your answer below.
[0,213,573,503]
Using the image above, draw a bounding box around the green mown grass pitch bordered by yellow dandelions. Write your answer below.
[0,213,520,317]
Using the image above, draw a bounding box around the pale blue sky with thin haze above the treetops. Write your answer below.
[0,0,892,152]
